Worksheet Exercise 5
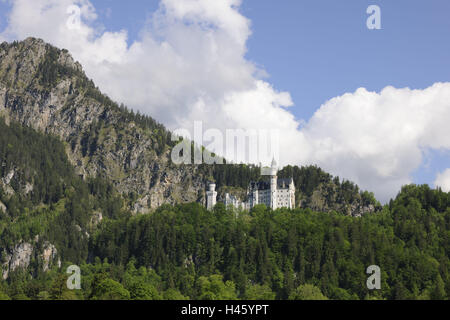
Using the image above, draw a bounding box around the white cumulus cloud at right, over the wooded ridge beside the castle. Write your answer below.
[302,83,450,200]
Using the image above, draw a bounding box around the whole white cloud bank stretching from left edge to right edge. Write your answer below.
[0,0,450,201]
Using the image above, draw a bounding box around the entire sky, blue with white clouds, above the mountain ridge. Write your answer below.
[0,0,450,201]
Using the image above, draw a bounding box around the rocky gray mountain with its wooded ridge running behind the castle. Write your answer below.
[0,38,376,215]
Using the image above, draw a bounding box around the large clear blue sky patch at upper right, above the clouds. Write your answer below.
[243,0,450,118]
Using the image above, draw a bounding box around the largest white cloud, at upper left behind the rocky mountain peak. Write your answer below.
[3,0,298,161]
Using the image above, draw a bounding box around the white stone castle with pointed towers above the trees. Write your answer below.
[206,160,295,210]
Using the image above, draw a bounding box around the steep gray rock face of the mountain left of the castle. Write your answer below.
[0,38,204,212]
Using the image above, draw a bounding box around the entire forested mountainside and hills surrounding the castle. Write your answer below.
[0,38,450,299]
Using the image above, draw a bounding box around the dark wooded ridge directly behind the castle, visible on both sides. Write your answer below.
[200,164,381,216]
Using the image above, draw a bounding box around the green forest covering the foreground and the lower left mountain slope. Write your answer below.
[0,119,450,300]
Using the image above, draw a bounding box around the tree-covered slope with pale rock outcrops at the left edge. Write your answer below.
[0,118,130,278]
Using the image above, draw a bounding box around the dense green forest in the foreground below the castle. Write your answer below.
[0,186,450,300]
